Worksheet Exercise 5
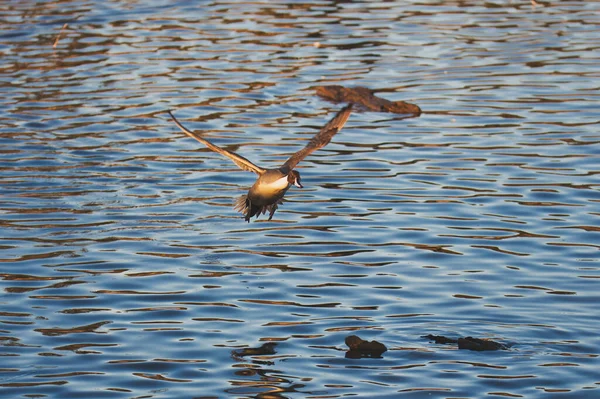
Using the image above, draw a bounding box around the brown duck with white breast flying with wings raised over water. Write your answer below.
[168,104,352,222]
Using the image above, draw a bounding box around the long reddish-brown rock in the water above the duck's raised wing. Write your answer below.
[317,85,421,116]
